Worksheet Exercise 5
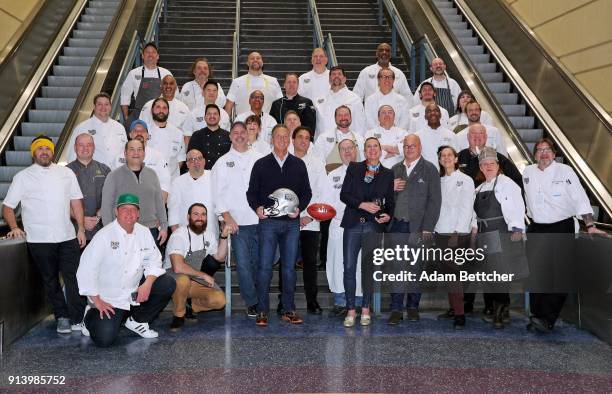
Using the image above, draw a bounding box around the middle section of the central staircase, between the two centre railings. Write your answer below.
[238,0,313,86]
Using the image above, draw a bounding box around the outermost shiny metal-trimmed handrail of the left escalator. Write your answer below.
[0,0,87,159]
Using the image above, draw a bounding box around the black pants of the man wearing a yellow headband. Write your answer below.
[27,238,87,324]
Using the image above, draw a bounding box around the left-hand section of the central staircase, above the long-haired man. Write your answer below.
[159,0,236,94]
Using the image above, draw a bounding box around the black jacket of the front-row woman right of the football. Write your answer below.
[340,161,395,232]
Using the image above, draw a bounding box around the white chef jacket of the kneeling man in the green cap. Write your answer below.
[76,219,166,310]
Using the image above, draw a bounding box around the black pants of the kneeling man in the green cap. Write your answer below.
[85,274,176,347]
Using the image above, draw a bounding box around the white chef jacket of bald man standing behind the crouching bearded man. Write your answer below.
[168,170,219,239]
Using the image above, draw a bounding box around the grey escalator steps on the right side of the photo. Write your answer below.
[433,0,543,152]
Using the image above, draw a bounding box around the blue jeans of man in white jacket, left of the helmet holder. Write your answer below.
[232,224,259,307]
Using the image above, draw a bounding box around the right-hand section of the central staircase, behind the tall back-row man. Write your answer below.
[317,0,410,89]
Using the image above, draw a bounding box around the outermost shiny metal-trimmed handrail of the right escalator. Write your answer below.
[454,0,612,216]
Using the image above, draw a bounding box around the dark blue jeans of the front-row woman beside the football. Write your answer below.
[342,222,378,310]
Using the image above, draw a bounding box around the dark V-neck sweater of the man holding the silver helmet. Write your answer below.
[247,153,312,219]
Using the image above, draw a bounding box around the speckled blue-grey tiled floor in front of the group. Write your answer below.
[0,312,612,393]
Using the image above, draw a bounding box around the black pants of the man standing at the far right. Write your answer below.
[527,218,574,326]
